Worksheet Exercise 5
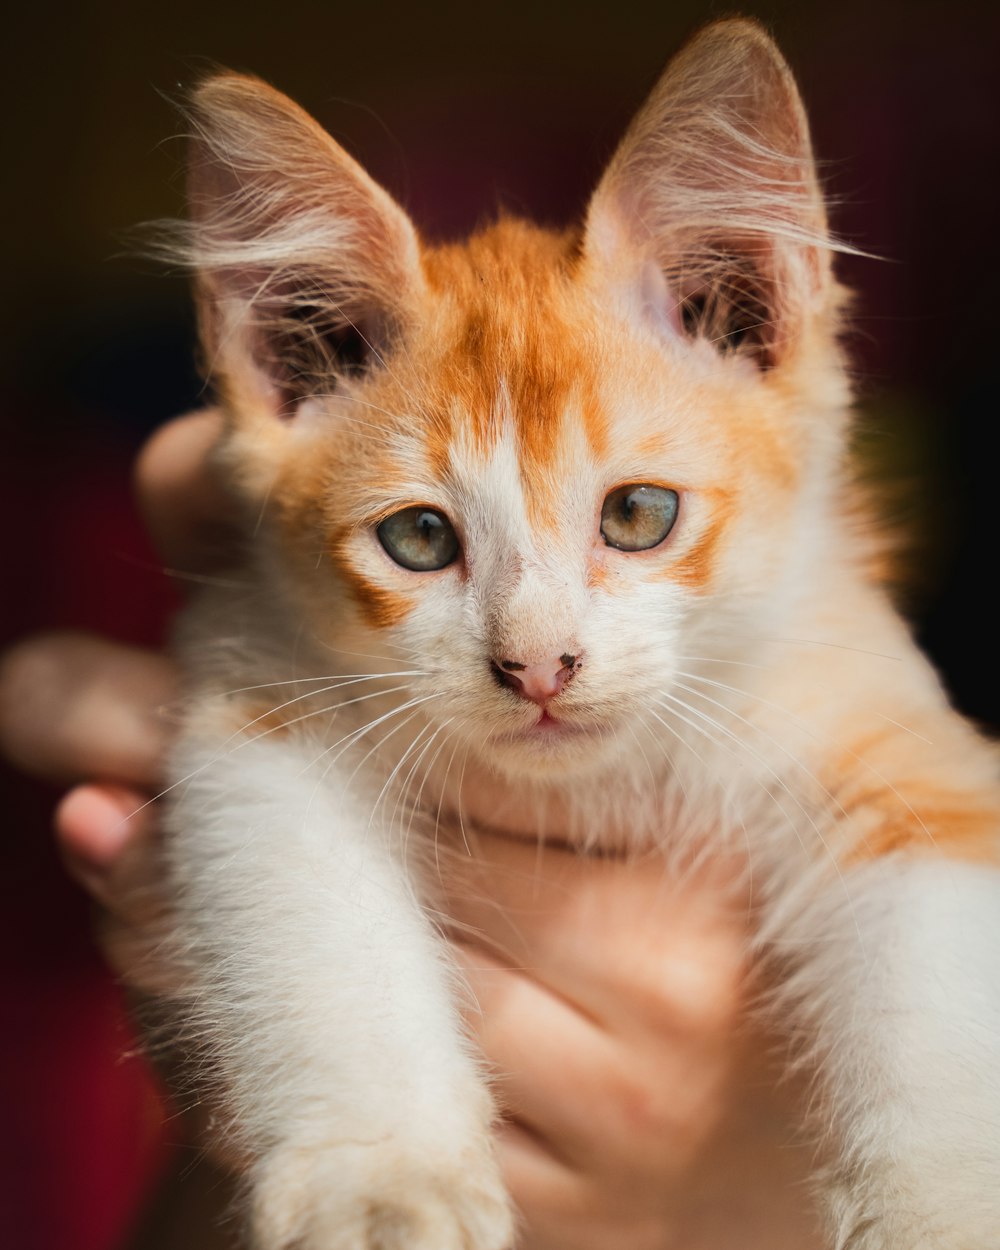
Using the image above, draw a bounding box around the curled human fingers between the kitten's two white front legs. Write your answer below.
[446,839,746,1235]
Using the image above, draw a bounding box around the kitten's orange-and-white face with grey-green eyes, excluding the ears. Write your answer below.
[256,223,835,776]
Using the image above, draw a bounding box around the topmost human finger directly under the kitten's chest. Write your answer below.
[441,835,748,1036]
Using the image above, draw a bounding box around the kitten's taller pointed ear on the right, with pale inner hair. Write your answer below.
[585,19,833,368]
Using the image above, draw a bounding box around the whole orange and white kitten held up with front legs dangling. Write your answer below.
[160,20,1000,1250]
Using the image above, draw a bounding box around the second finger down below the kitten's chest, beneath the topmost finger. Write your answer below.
[459,948,740,1180]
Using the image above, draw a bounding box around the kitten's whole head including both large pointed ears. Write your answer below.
[177,21,846,775]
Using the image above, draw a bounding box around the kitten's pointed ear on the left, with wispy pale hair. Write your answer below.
[181,74,423,418]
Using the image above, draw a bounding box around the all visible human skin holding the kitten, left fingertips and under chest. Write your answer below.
[0,411,821,1250]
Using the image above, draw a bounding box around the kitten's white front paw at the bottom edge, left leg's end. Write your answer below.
[253,1141,514,1250]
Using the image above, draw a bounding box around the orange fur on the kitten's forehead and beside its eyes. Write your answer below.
[257,219,799,615]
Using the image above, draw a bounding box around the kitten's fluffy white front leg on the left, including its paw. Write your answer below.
[170,738,511,1250]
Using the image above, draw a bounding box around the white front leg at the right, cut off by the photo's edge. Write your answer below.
[785,859,1000,1250]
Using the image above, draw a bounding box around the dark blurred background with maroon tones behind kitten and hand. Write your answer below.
[0,0,1000,1250]
